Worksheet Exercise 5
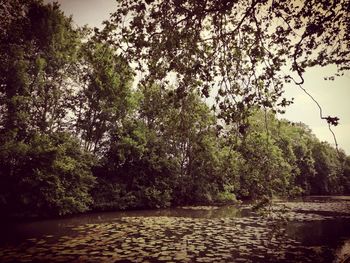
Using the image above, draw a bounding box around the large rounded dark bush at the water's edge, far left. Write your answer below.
[0,133,94,216]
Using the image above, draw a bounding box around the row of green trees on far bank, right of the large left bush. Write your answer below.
[93,85,350,210]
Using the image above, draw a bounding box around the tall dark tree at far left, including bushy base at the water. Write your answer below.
[0,0,94,219]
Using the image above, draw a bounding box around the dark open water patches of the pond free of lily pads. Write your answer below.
[0,196,350,260]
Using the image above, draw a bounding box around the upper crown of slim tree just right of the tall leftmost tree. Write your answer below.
[75,38,133,152]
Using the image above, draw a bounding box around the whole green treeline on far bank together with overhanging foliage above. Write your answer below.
[0,0,350,217]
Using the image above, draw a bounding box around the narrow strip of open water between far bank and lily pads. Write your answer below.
[0,205,251,245]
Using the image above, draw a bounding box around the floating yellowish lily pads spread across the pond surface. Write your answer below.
[0,203,350,262]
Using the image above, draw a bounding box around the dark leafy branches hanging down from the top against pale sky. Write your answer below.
[100,0,350,124]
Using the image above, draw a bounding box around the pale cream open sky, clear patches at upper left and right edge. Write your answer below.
[44,0,350,155]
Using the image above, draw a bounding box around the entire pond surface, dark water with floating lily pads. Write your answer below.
[0,196,350,262]
